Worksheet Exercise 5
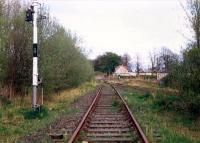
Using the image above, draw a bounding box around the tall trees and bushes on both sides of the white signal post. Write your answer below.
[0,0,93,96]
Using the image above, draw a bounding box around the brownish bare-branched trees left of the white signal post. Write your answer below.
[0,1,32,97]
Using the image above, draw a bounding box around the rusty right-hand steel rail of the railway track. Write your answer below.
[110,84,149,143]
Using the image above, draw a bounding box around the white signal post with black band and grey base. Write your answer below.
[32,0,39,109]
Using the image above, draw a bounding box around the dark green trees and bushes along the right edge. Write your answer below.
[158,0,200,117]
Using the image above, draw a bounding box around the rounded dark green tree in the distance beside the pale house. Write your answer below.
[94,52,122,75]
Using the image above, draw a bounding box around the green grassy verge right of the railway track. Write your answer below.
[123,91,200,143]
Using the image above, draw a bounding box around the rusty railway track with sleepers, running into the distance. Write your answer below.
[69,85,148,143]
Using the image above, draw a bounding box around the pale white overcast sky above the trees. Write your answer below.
[37,0,190,65]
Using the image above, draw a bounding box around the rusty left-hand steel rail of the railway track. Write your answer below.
[68,88,102,143]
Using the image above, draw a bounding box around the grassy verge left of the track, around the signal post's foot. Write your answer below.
[0,82,96,142]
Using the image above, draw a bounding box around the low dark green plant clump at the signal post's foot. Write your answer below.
[20,107,48,120]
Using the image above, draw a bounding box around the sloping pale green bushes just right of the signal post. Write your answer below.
[40,26,93,92]
